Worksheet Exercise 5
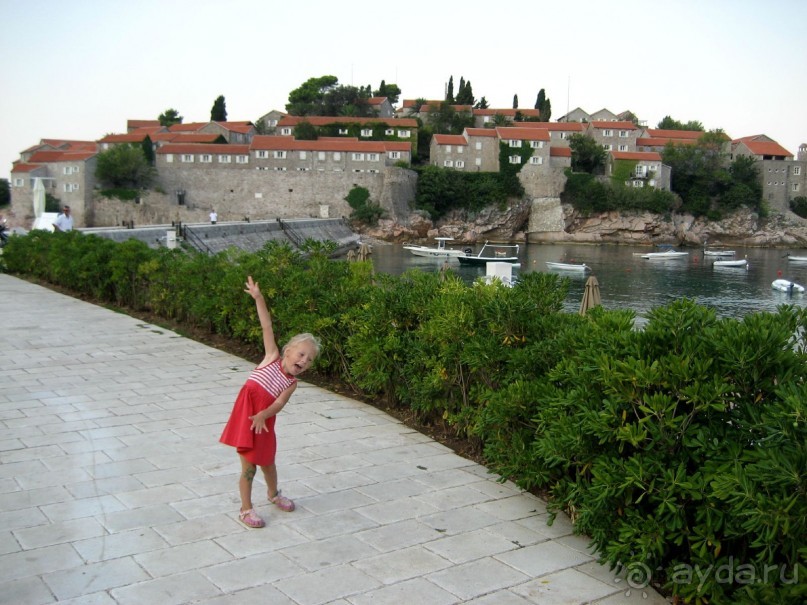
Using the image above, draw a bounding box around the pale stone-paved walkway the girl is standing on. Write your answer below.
[0,274,667,605]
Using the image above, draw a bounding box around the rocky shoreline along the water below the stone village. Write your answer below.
[354,202,807,248]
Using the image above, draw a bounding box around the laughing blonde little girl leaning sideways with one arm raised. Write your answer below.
[219,275,320,527]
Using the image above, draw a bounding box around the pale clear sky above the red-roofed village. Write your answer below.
[0,0,807,178]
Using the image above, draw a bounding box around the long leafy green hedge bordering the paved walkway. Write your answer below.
[2,231,807,603]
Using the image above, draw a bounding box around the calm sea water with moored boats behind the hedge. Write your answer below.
[370,244,807,318]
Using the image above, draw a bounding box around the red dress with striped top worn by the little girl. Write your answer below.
[219,358,297,466]
